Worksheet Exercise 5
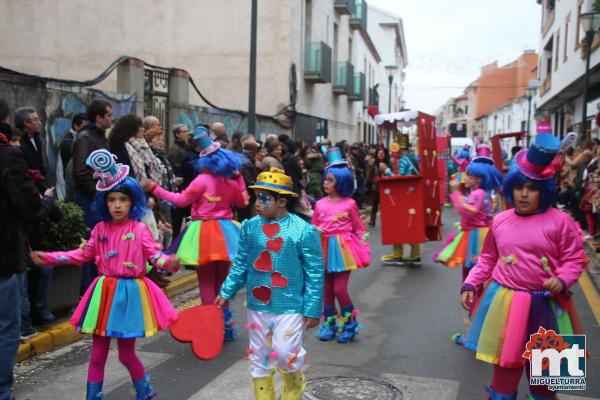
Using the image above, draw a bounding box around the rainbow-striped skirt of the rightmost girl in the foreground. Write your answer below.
[464,281,583,368]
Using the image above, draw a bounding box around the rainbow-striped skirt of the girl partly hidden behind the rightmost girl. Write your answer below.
[436,228,489,268]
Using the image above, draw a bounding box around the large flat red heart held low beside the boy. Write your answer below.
[171,304,225,360]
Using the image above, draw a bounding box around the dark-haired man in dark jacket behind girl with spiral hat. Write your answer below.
[72,100,112,294]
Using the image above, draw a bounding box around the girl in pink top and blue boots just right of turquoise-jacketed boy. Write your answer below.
[312,147,371,343]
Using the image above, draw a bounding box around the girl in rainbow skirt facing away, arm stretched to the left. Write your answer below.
[142,125,249,340]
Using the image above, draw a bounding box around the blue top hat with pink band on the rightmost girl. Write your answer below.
[515,133,560,181]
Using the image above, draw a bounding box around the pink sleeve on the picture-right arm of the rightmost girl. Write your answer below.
[555,217,586,289]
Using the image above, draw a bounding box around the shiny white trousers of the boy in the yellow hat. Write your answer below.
[246,310,306,378]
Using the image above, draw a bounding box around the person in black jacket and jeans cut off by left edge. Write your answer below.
[0,97,41,400]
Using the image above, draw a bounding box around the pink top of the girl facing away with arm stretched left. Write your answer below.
[152,173,248,220]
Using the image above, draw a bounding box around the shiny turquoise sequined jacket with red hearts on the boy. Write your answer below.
[220,214,324,318]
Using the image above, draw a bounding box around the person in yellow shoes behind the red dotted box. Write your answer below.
[380,134,421,265]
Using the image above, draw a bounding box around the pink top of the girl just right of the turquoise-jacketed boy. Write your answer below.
[311,197,367,239]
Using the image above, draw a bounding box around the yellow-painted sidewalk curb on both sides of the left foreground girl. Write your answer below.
[17,274,198,362]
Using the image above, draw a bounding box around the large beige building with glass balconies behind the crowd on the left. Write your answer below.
[0,0,404,141]
